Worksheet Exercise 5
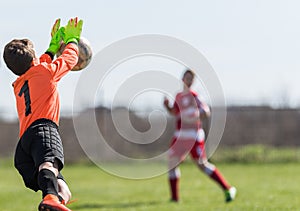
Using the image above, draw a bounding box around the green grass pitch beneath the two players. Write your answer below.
[0,160,300,211]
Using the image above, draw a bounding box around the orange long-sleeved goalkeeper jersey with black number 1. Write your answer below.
[13,43,78,137]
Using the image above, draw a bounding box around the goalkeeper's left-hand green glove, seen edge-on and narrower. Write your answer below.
[47,19,64,55]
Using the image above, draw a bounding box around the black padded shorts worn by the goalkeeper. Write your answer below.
[14,119,64,191]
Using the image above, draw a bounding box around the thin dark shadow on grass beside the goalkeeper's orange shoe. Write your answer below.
[72,201,161,210]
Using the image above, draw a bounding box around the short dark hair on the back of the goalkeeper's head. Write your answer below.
[3,39,35,76]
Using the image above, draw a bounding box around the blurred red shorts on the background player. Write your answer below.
[169,137,206,161]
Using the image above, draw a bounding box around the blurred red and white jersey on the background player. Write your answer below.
[173,91,208,131]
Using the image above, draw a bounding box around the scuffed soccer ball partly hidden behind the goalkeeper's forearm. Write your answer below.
[56,37,93,71]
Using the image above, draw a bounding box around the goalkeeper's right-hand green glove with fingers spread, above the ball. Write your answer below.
[63,17,83,44]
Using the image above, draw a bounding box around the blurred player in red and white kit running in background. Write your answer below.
[164,70,236,202]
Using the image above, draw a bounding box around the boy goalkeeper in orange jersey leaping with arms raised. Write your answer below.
[3,18,83,211]
